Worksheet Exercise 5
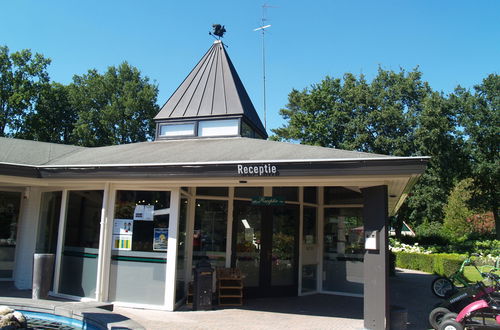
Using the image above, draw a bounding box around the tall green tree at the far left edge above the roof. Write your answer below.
[0,46,50,136]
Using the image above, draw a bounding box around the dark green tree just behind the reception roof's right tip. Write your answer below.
[406,92,468,225]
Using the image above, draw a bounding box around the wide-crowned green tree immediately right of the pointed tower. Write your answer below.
[273,68,430,156]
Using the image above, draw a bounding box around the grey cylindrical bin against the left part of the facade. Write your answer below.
[32,253,55,299]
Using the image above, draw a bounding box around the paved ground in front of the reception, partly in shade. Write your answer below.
[0,270,439,330]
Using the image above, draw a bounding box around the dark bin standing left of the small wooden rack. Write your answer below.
[193,259,214,311]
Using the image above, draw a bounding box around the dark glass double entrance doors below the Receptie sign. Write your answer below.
[231,201,300,297]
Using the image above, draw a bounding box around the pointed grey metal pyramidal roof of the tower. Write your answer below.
[154,40,267,137]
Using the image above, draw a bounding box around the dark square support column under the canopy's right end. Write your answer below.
[361,186,390,330]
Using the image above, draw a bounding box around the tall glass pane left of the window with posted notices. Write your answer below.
[59,190,103,298]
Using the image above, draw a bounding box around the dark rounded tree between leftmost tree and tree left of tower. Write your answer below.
[16,83,77,144]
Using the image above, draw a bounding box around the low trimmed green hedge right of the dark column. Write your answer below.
[394,252,466,276]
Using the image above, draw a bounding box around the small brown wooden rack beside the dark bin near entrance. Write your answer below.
[216,268,243,306]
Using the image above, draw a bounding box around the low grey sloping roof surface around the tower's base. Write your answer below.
[0,137,428,169]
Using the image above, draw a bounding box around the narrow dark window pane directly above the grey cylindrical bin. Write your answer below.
[36,191,62,253]
